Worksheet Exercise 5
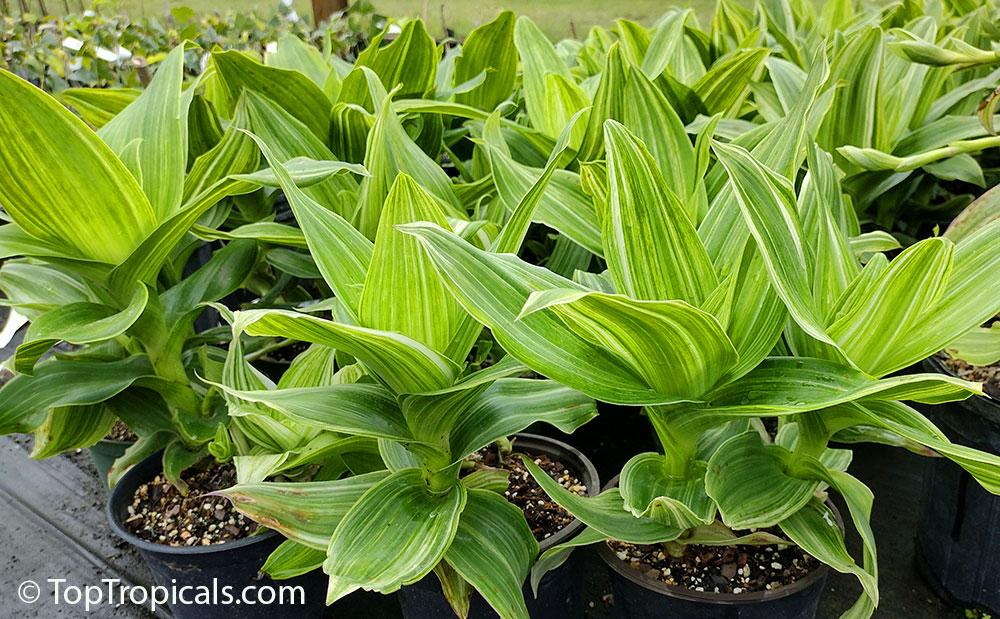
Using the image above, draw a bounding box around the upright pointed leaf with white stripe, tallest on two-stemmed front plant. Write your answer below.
[603,121,717,306]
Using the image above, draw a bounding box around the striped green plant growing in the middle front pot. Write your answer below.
[198,108,596,617]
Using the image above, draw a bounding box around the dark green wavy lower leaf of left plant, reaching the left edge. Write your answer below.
[0,355,153,434]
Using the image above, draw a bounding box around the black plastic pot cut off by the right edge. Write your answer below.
[916,358,1000,614]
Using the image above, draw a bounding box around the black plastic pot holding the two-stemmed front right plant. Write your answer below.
[594,477,832,619]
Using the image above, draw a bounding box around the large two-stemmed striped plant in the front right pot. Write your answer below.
[402,111,1000,616]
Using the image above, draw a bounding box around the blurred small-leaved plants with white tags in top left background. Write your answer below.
[0,0,386,92]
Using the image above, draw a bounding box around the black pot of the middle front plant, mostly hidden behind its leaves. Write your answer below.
[399,432,600,619]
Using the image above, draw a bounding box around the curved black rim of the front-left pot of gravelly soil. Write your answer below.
[105,451,279,555]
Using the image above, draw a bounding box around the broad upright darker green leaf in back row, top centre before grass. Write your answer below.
[454,11,517,111]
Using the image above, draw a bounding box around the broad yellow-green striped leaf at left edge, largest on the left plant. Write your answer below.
[0,72,156,264]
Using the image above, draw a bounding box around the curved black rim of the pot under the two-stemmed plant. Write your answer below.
[595,475,844,606]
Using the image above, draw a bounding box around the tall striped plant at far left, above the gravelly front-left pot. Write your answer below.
[0,46,348,616]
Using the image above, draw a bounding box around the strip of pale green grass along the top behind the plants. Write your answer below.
[39,0,715,40]
